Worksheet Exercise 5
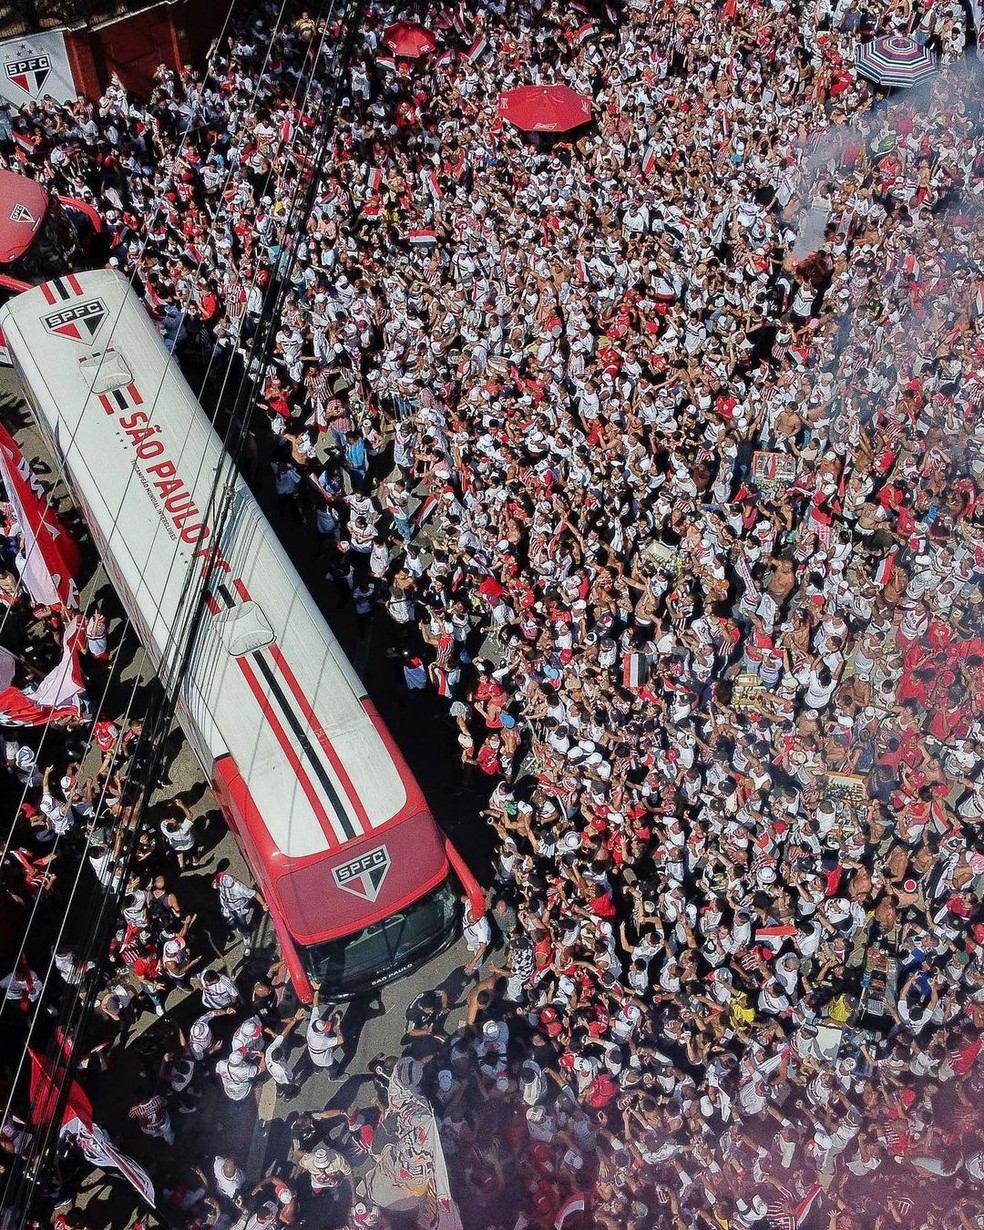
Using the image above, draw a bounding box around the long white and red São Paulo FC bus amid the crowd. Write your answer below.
[0,269,482,1001]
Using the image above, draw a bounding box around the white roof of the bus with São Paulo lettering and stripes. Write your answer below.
[0,269,413,859]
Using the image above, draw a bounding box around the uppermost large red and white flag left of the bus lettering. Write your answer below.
[0,426,81,608]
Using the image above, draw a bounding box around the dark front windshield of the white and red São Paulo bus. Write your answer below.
[301,881,458,998]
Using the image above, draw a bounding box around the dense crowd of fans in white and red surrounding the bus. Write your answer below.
[5,0,984,1230]
